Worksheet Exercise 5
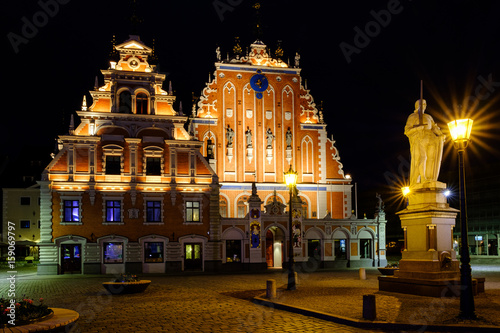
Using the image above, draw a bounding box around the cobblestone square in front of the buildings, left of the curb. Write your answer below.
[0,272,382,333]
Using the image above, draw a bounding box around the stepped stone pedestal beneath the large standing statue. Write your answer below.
[379,182,460,297]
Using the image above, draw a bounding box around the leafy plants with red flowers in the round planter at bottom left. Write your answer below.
[0,297,54,327]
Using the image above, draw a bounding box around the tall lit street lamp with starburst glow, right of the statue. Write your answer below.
[448,119,476,319]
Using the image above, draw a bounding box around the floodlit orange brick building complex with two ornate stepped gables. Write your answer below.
[38,36,386,274]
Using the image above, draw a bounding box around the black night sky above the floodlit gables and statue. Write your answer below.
[0,0,500,233]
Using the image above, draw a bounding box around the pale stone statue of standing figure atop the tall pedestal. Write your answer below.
[405,100,445,187]
